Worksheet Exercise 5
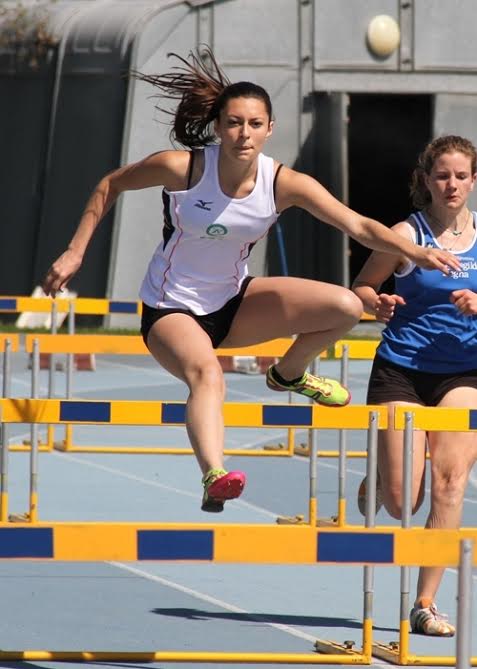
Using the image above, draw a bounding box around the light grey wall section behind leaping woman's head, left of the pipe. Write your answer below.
[108,0,301,323]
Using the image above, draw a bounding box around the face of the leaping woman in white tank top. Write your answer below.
[215,97,273,161]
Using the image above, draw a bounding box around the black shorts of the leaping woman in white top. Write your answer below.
[141,276,253,348]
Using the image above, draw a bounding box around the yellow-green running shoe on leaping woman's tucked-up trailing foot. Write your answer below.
[266,365,351,407]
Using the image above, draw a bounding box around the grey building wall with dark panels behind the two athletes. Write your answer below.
[0,0,477,325]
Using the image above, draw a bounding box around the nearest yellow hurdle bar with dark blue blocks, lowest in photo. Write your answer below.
[0,521,477,567]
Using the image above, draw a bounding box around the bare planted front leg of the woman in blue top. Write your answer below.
[416,387,477,602]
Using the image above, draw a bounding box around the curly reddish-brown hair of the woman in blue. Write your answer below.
[410,135,477,209]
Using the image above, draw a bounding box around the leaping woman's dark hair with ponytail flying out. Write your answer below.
[132,47,272,149]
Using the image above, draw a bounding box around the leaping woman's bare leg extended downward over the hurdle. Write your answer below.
[147,314,225,474]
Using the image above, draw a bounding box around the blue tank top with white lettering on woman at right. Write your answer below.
[378,212,477,374]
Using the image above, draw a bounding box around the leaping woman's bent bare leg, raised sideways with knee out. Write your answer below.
[222,277,362,379]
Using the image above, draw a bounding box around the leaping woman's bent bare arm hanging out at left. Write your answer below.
[43,151,190,297]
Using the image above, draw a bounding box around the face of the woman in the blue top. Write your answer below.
[426,151,476,209]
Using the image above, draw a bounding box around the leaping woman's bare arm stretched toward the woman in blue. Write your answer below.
[277,168,459,274]
